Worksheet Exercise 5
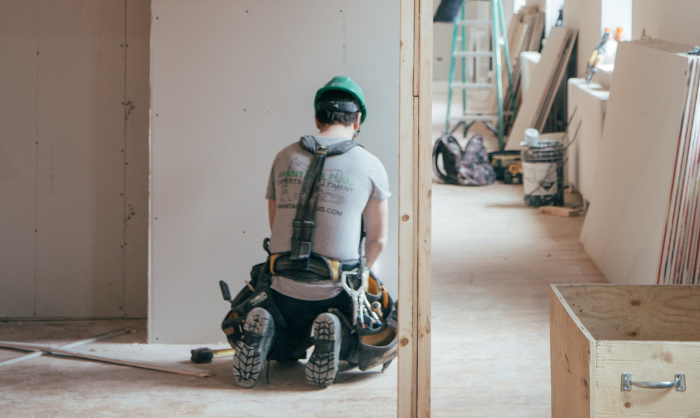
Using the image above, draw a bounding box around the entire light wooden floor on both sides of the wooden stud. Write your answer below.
[0,184,602,418]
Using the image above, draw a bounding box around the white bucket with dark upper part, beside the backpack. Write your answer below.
[522,141,566,208]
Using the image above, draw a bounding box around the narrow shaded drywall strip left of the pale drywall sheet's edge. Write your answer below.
[124,0,151,318]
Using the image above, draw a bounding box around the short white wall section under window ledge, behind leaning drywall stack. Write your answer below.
[567,78,610,203]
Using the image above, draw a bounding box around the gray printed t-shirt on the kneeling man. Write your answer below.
[266,138,391,300]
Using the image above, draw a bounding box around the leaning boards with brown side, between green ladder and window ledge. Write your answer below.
[506,26,578,150]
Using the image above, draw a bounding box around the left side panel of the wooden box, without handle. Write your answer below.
[549,285,596,418]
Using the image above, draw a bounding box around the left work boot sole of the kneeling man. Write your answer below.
[233,308,275,388]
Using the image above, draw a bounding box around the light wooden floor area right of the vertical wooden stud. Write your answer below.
[432,184,604,418]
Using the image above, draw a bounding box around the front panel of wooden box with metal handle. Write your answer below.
[595,341,700,418]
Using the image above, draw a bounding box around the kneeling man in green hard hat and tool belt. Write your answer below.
[222,76,396,388]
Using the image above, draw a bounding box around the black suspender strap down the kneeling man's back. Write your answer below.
[289,135,361,270]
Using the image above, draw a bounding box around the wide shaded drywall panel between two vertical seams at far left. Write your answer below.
[36,0,124,317]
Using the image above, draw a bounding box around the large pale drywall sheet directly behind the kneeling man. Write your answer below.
[149,0,399,343]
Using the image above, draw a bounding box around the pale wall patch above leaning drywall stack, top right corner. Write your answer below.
[632,0,700,45]
